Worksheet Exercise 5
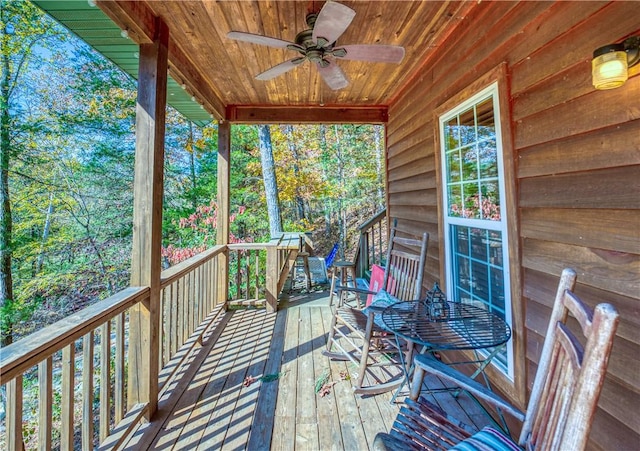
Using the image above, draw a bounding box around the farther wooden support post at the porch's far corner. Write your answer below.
[216,121,231,309]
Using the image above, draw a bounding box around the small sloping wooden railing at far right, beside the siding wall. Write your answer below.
[356,209,389,277]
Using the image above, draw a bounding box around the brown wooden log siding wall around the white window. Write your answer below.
[387,2,640,449]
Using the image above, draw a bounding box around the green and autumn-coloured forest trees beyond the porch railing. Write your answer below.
[0,0,384,346]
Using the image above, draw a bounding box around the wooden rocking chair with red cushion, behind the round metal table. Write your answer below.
[323,228,429,394]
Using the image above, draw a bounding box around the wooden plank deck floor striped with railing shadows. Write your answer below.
[126,292,487,451]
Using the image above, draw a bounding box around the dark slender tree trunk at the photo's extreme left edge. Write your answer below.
[0,33,13,346]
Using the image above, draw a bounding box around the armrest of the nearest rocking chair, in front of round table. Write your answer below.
[412,354,525,421]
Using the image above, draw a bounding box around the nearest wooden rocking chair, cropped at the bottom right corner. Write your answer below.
[374,269,618,451]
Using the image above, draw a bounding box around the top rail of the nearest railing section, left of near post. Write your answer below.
[0,287,149,383]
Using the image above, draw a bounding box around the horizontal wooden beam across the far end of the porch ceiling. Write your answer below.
[226,105,389,124]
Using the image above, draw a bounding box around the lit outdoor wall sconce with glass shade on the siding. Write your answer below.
[591,36,640,89]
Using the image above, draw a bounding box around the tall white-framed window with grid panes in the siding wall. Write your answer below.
[439,82,514,380]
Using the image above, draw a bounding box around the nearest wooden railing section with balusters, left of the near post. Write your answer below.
[0,287,149,450]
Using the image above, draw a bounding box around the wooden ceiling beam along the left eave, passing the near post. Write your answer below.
[97,0,225,120]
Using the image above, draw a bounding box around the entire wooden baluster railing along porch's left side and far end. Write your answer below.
[0,235,309,451]
